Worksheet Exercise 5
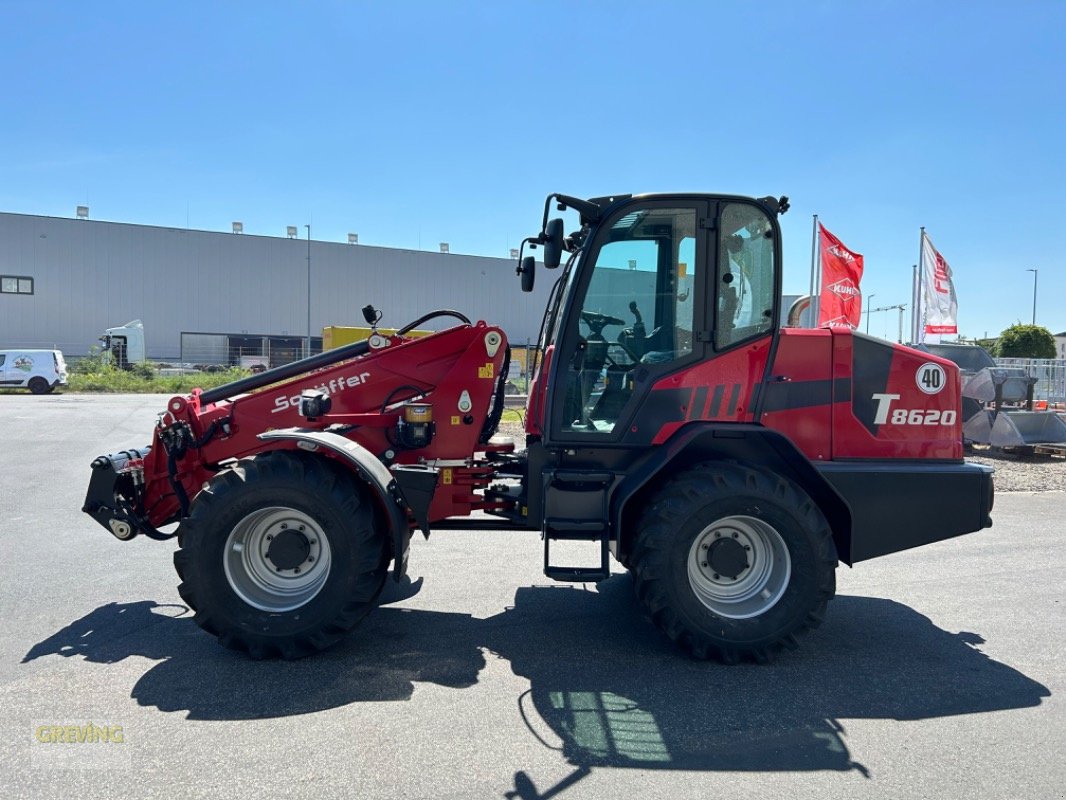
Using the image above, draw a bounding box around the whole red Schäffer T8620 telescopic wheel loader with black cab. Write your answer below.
[83,194,994,662]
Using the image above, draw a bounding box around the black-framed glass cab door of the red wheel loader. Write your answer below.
[547,195,711,445]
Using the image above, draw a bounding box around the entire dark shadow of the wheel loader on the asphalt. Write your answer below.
[23,576,1050,780]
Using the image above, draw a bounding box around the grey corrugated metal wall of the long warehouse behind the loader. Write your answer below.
[0,213,559,358]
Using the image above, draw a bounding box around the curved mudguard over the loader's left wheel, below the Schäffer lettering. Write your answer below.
[258,428,435,581]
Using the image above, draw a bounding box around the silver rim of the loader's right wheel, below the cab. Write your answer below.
[688,516,792,620]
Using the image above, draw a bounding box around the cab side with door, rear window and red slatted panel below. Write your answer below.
[546,195,780,446]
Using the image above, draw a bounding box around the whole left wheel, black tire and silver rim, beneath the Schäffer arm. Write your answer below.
[174,452,389,659]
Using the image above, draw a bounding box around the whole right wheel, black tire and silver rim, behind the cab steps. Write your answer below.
[630,463,837,663]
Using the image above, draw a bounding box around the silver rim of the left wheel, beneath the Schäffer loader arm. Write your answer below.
[223,506,330,612]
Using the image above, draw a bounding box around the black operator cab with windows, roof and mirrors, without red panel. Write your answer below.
[526,195,787,443]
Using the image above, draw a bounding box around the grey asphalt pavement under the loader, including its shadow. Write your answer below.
[0,395,1066,800]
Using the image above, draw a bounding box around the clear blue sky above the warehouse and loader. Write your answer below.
[0,0,1066,338]
